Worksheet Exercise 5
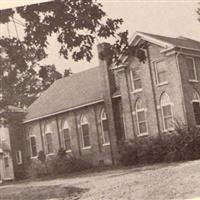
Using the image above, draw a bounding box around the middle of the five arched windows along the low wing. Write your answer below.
[62,120,71,151]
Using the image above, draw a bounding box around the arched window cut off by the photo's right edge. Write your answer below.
[192,91,200,125]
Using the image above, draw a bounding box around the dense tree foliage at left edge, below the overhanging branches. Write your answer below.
[0,38,62,106]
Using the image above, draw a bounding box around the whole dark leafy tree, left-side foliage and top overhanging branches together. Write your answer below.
[0,0,144,107]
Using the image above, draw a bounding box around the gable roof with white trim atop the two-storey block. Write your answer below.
[131,32,200,50]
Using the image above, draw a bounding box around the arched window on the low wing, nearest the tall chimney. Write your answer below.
[101,109,110,145]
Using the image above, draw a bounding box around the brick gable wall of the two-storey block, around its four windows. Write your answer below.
[118,44,186,140]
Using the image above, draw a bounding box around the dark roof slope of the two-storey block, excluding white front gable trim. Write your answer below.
[138,32,200,50]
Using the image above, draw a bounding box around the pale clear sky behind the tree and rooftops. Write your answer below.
[0,0,200,72]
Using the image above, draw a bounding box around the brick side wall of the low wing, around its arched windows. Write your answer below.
[23,100,126,165]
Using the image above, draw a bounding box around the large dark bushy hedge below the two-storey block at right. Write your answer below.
[120,126,200,166]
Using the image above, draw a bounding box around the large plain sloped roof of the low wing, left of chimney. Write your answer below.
[25,67,103,122]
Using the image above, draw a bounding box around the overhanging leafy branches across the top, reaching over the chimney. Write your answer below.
[0,0,147,62]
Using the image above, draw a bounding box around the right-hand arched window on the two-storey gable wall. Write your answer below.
[160,93,174,131]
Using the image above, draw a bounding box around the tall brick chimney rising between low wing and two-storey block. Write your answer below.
[97,43,118,164]
